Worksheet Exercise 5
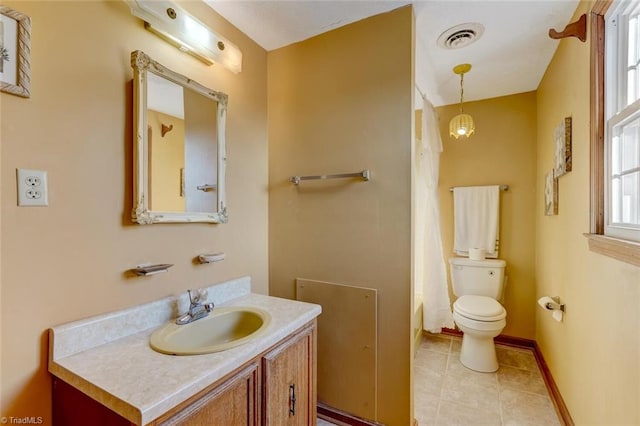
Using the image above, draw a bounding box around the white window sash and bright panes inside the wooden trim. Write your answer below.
[604,2,640,241]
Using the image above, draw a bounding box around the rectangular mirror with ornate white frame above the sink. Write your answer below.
[131,50,228,225]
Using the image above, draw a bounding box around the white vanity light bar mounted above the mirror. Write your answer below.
[125,0,242,74]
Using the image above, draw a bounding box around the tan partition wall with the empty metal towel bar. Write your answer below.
[268,8,414,425]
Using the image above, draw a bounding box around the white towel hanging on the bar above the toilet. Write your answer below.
[453,185,500,258]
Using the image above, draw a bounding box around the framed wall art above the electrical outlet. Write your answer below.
[0,6,31,98]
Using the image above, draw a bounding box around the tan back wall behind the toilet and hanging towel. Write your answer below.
[437,93,537,339]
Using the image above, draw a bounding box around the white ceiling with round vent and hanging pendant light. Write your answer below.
[205,0,580,106]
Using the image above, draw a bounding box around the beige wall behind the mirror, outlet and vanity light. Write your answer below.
[0,1,268,424]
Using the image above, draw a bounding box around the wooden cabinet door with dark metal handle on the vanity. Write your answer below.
[262,321,316,426]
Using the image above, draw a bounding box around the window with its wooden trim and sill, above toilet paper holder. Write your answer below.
[587,0,640,266]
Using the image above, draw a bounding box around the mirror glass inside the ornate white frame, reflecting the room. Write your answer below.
[147,73,218,212]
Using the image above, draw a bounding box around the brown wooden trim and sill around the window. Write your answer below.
[585,0,640,266]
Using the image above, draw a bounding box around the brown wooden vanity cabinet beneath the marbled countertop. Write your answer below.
[53,320,317,426]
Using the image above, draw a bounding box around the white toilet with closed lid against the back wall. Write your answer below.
[449,257,507,373]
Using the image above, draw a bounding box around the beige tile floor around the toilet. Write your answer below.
[414,334,560,426]
